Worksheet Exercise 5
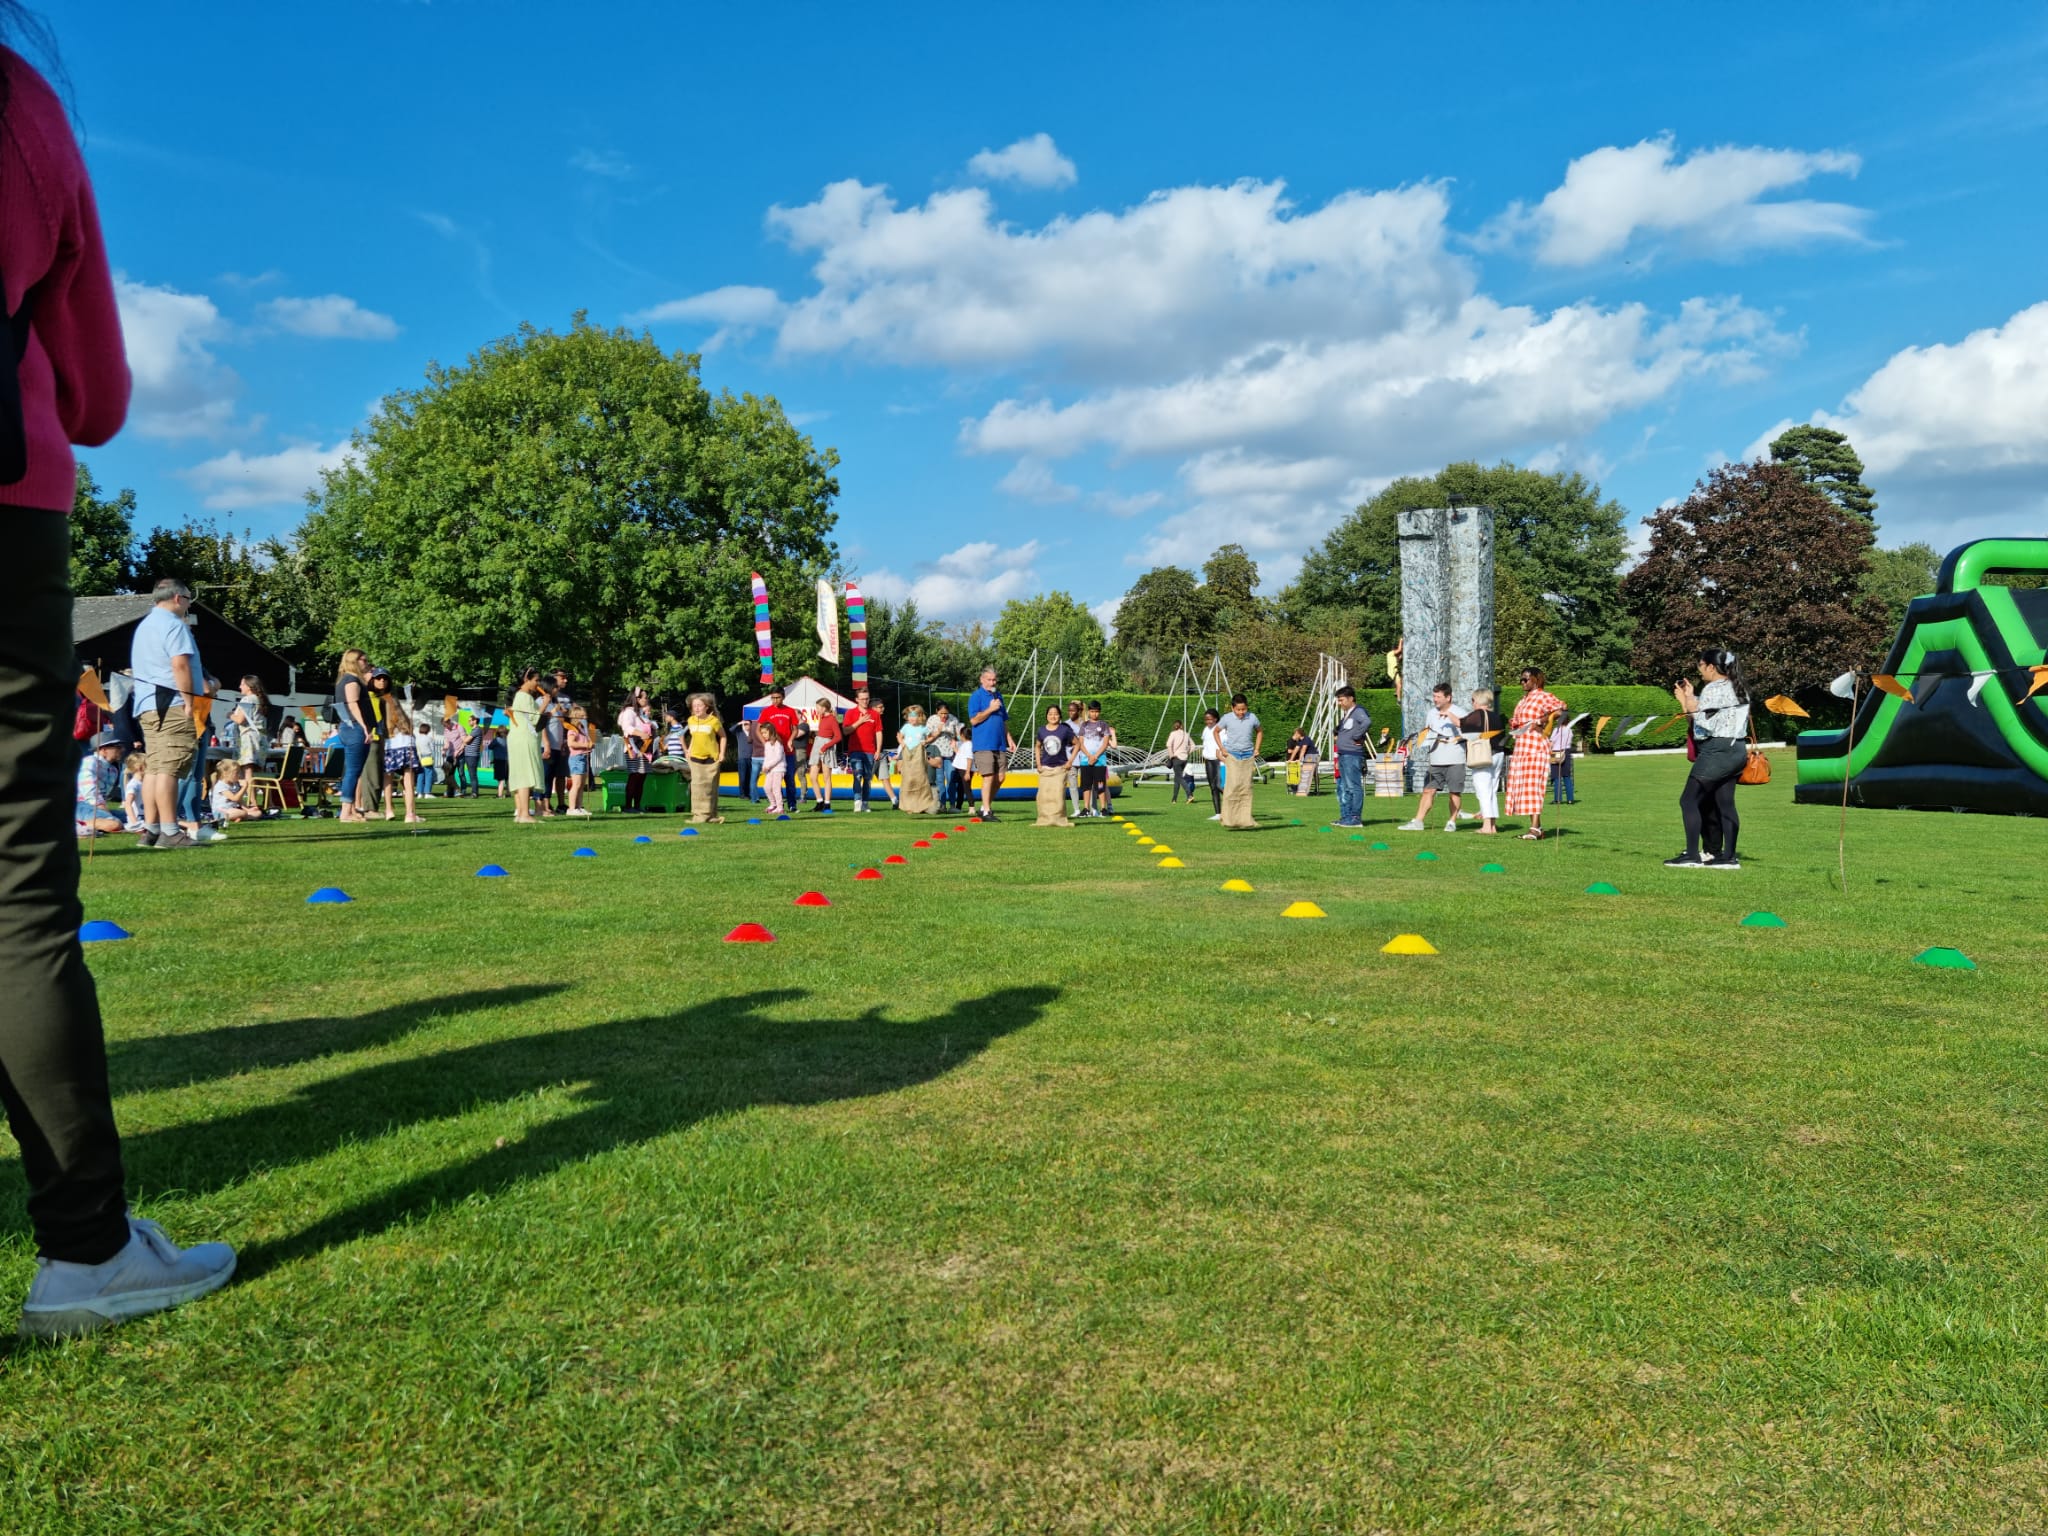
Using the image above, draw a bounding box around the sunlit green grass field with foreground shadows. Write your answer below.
[0,758,2048,1536]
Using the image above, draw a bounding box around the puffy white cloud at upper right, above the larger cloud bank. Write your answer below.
[1489,135,1870,266]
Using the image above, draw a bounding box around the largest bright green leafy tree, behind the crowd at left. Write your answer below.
[297,315,840,696]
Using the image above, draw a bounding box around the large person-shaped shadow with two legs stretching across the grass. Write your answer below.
[105,987,1059,1278]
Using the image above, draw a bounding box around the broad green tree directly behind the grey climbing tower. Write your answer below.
[1282,463,1630,682]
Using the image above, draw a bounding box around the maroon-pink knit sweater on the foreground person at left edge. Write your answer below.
[0,49,129,510]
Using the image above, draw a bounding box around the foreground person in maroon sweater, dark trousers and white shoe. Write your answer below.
[0,27,236,1337]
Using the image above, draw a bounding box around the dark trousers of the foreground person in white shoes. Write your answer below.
[0,506,129,1264]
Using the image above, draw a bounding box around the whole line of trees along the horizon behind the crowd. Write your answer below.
[72,315,1935,720]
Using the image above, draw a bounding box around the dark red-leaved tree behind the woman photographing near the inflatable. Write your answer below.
[1622,463,1890,698]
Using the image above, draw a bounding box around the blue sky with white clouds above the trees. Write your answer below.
[51,0,2048,618]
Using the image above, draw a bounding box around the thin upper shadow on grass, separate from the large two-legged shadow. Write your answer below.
[106,981,567,1094]
